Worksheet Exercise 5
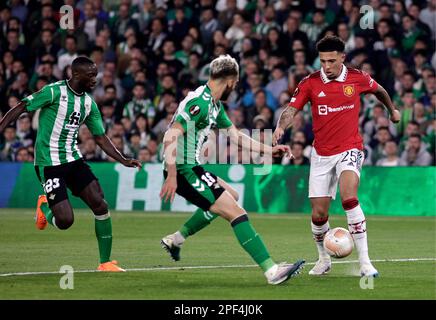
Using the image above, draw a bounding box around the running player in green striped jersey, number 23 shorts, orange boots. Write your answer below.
[0,57,141,271]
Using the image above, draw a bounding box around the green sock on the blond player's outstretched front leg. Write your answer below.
[232,214,275,272]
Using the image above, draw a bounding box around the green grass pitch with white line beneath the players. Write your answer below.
[0,209,436,300]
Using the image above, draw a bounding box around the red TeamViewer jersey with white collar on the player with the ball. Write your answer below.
[289,66,378,156]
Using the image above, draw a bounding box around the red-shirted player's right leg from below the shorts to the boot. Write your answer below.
[339,170,378,277]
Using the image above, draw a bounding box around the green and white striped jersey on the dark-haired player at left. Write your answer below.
[23,80,105,166]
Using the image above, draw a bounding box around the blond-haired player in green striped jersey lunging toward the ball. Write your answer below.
[160,55,304,284]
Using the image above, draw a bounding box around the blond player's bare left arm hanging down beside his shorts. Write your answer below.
[160,122,184,202]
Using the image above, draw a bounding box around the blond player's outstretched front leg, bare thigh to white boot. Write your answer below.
[209,191,304,284]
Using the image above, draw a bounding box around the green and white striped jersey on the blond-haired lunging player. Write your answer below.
[169,85,232,170]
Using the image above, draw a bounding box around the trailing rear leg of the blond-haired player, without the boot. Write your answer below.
[168,177,239,245]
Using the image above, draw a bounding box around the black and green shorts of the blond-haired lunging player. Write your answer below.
[164,166,225,211]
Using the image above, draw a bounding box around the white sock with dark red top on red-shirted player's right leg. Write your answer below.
[342,198,370,265]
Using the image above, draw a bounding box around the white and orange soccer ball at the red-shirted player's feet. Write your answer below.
[324,228,354,258]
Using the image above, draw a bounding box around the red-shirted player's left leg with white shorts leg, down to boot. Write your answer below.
[309,148,338,275]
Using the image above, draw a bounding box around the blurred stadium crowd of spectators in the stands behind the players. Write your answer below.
[0,0,436,166]
